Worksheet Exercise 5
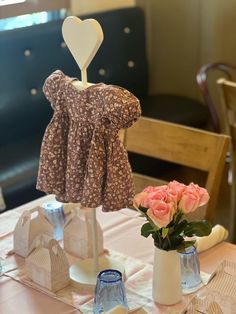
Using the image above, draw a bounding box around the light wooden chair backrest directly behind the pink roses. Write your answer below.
[124,117,229,220]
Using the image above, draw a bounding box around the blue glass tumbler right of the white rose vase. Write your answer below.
[180,246,202,291]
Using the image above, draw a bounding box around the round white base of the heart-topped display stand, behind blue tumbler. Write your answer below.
[70,257,125,292]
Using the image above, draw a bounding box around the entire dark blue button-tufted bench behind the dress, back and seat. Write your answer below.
[0,8,207,209]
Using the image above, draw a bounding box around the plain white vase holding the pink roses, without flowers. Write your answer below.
[152,247,182,305]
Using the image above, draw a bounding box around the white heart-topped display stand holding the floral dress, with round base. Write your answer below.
[62,16,124,289]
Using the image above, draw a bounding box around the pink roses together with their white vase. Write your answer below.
[134,181,212,305]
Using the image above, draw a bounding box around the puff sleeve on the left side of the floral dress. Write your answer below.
[43,70,65,109]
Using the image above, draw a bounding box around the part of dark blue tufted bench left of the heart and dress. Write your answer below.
[0,17,79,208]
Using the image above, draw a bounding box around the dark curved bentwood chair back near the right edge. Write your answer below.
[197,62,236,133]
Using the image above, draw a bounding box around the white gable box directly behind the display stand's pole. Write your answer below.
[64,208,104,259]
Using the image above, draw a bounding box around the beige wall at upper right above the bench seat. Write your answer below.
[136,0,236,99]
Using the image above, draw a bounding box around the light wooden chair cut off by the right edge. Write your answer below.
[217,78,236,243]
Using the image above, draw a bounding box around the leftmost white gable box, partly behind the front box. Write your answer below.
[13,206,53,257]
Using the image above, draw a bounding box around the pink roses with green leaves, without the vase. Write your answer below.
[134,181,212,251]
